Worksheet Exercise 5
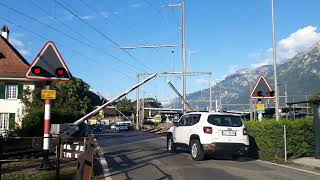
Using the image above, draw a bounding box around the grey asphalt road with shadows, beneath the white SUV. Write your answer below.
[96,132,320,180]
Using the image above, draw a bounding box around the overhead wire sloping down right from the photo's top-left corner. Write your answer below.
[0,2,146,70]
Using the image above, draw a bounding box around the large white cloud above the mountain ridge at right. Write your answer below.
[248,26,320,68]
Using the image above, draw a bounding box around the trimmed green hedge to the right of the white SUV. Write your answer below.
[245,118,315,162]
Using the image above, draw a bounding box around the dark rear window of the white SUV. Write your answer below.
[208,115,242,127]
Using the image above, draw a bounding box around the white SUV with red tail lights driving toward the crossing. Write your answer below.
[167,112,249,160]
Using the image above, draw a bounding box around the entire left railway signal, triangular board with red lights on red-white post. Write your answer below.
[26,41,72,169]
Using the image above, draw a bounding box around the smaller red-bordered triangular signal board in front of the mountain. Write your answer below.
[250,76,275,99]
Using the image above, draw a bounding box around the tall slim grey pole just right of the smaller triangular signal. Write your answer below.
[271,0,279,121]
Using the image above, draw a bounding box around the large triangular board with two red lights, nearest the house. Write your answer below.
[26,41,72,81]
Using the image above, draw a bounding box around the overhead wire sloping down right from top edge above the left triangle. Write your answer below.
[55,0,152,71]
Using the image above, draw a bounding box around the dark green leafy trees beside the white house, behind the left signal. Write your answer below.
[17,78,94,136]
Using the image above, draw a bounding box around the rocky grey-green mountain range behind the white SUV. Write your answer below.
[169,43,320,110]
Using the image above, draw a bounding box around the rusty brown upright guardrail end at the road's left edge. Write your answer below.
[77,136,96,180]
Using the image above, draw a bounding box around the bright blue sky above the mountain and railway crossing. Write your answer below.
[0,0,320,100]
